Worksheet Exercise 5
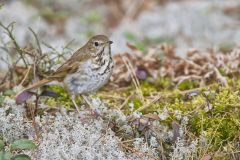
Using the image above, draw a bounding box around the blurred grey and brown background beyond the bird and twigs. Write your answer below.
[0,0,240,55]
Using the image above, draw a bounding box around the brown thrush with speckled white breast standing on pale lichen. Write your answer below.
[18,35,113,112]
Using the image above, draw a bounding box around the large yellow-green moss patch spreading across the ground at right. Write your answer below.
[135,81,240,154]
